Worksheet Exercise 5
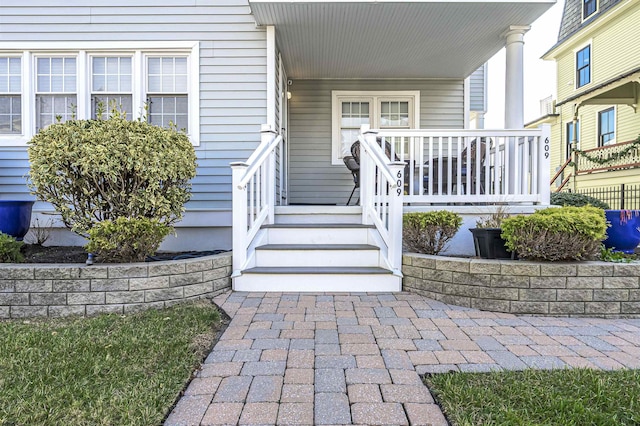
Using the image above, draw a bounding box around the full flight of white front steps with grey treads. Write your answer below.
[233,206,402,292]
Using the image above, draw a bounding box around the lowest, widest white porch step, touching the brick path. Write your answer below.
[233,267,402,293]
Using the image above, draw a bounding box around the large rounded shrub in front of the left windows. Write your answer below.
[28,113,196,236]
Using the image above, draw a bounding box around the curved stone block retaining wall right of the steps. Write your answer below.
[402,253,640,318]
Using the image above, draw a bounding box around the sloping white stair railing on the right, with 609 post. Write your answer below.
[358,128,405,276]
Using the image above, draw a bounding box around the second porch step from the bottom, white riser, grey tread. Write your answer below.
[256,244,380,267]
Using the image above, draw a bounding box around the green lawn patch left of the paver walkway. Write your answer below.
[0,302,220,426]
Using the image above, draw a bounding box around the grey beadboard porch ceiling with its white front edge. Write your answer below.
[249,0,556,79]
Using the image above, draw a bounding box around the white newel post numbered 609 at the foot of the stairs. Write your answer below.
[388,161,406,275]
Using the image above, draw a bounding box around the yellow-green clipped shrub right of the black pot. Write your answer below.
[502,206,607,261]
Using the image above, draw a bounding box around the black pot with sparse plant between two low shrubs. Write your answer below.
[469,206,515,259]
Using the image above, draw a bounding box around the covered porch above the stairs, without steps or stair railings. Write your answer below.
[250,0,555,205]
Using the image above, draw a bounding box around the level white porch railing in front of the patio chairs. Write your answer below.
[372,125,550,204]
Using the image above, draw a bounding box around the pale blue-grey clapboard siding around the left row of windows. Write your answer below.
[0,0,266,216]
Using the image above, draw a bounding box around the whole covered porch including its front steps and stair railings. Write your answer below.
[232,0,555,291]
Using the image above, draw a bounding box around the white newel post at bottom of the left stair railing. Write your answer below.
[231,162,249,276]
